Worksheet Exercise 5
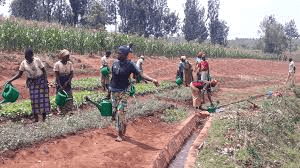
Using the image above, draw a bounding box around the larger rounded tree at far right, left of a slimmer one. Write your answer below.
[260,15,288,55]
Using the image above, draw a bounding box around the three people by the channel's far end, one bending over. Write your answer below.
[176,52,218,110]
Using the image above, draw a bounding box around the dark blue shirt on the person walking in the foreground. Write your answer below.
[109,60,140,92]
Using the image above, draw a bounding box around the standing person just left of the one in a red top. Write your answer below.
[177,56,193,86]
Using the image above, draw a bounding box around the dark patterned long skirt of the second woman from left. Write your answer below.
[56,75,74,114]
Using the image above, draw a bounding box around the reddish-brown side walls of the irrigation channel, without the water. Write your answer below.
[150,111,211,168]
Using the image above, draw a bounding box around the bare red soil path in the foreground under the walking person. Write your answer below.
[0,116,176,168]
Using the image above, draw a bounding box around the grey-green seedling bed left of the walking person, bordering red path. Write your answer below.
[0,111,109,150]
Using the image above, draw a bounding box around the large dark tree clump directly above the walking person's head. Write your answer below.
[118,0,178,38]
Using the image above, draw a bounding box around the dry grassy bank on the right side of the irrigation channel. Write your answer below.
[196,97,300,167]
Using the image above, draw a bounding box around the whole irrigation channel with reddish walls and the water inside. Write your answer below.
[151,112,211,168]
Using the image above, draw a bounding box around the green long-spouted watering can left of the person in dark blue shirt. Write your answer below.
[85,96,112,116]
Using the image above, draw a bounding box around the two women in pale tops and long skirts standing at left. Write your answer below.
[6,48,74,122]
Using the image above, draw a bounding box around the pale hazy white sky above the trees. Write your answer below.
[0,0,300,39]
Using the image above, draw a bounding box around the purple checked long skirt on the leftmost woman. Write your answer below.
[27,75,50,114]
